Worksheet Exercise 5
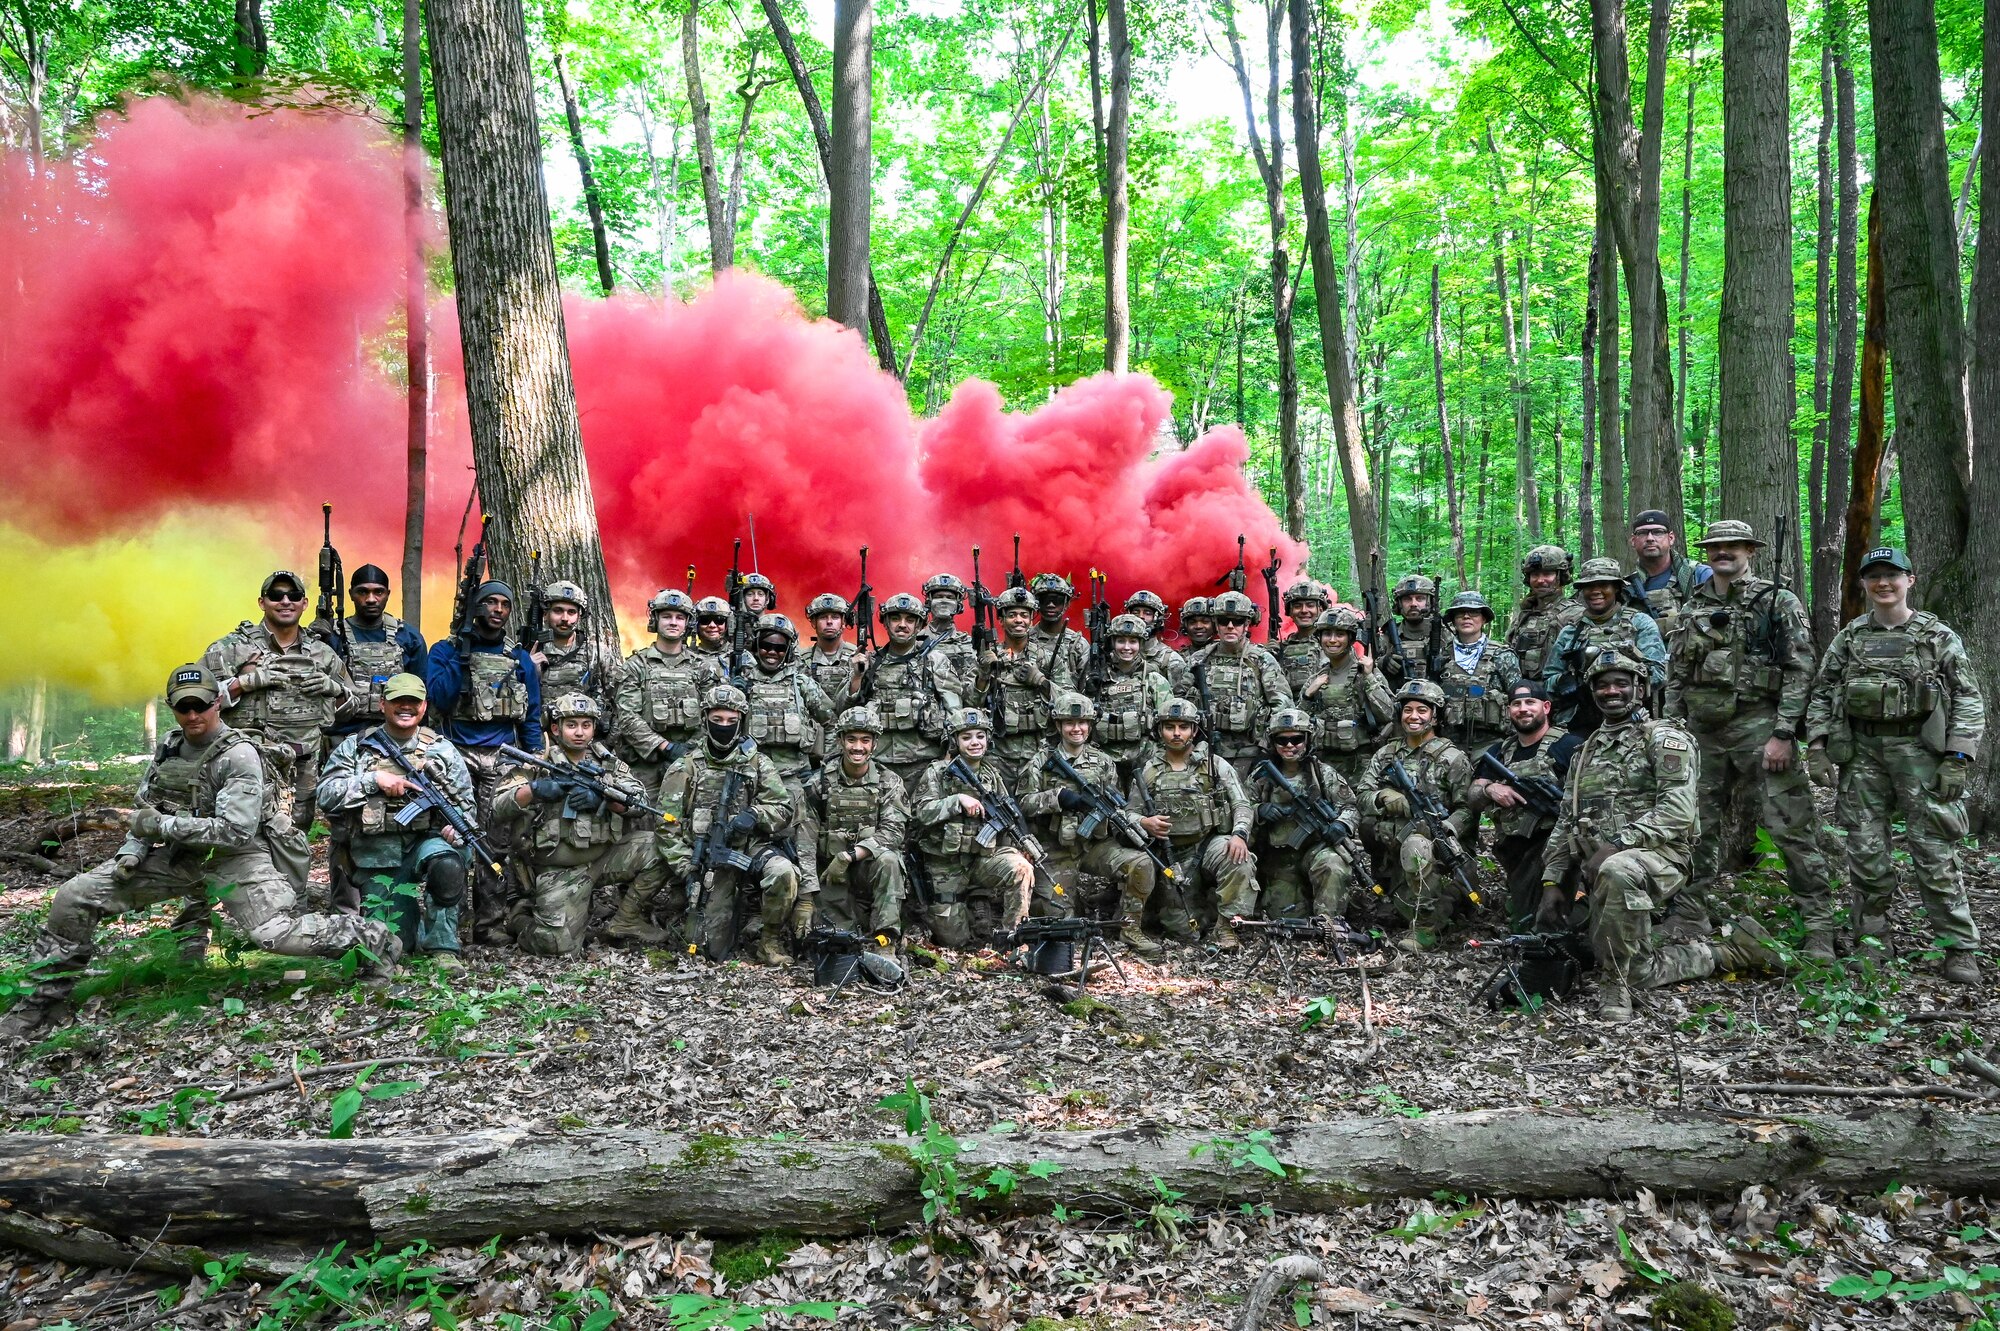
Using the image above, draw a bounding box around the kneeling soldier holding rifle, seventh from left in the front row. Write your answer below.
[1020,699,1160,957]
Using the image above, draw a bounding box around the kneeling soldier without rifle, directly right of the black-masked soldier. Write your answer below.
[798,707,910,957]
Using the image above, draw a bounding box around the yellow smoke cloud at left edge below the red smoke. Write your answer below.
[0,516,286,703]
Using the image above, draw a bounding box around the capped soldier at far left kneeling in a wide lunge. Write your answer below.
[0,666,402,1045]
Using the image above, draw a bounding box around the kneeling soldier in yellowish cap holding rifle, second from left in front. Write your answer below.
[318,673,478,969]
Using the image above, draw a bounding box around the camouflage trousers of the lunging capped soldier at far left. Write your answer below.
[36,841,390,991]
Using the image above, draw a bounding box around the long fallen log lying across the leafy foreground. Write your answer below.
[0,1107,2000,1251]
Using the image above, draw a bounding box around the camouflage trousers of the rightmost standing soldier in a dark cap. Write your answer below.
[1836,735,1980,947]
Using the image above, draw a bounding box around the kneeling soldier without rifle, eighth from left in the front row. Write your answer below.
[1132,695,1276,951]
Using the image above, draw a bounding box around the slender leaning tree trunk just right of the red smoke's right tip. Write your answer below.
[1290,0,1386,592]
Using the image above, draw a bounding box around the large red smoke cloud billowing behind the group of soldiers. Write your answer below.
[0,98,1304,647]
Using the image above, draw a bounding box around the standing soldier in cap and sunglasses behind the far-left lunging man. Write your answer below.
[206,570,358,887]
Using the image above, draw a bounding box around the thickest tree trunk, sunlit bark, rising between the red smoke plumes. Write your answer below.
[426,0,620,652]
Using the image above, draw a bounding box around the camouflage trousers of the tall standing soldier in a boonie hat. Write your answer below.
[1692,707,1834,931]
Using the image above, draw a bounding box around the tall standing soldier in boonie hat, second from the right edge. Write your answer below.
[1666,520,1834,961]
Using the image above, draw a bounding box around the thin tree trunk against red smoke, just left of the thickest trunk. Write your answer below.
[402,0,430,624]
